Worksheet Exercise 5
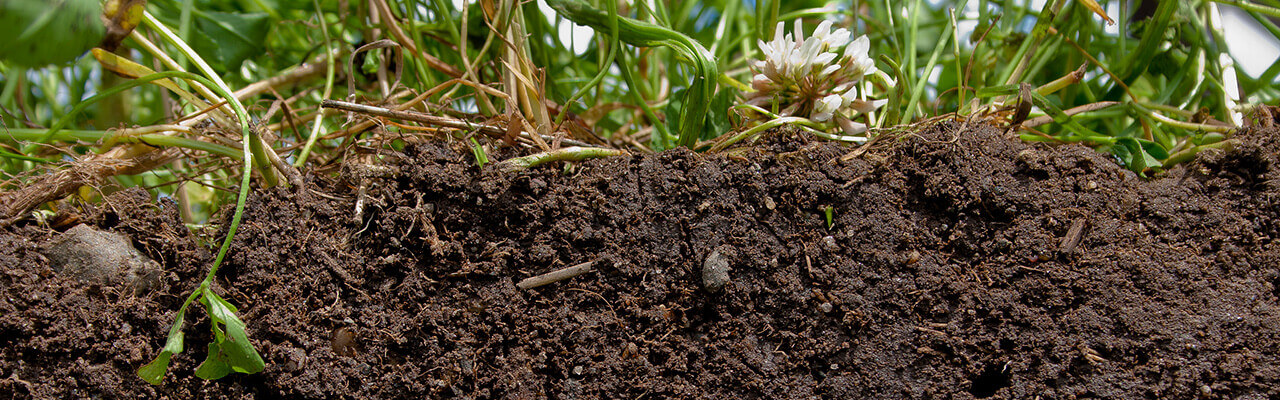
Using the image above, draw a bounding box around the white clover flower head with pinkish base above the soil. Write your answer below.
[746,19,886,135]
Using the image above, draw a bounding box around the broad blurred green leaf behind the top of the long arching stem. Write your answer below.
[193,12,271,72]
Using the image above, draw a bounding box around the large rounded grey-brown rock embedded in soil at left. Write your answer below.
[45,224,160,295]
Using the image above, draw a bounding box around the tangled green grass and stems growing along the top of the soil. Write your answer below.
[0,0,1280,383]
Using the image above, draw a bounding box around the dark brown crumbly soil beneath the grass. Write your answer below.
[0,123,1280,399]
